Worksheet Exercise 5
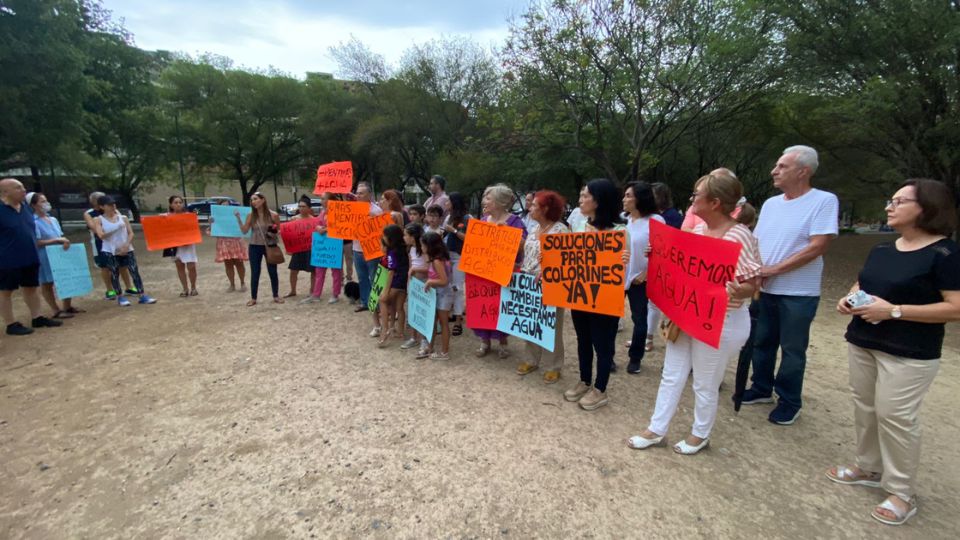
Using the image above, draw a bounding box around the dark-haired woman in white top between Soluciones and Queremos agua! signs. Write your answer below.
[623,182,664,374]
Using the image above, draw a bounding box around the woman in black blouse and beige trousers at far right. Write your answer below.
[827,179,960,525]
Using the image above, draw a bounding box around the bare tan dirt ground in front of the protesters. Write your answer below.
[0,235,960,539]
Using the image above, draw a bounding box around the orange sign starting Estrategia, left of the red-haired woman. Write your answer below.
[460,219,523,286]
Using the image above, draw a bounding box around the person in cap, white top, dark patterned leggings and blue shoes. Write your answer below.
[94,195,157,307]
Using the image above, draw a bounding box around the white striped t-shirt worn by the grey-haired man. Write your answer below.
[755,189,840,296]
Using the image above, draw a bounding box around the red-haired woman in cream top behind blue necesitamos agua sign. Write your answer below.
[517,190,570,384]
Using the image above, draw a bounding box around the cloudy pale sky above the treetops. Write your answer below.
[104,0,528,78]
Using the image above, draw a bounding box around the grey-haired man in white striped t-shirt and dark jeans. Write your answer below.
[743,146,839,425]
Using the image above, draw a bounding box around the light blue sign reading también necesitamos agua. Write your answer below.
[497,273,557,351]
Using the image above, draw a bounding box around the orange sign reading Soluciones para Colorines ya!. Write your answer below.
[540,231,643,317]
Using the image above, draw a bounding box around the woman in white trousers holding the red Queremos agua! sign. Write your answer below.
[628,174,762,455]
